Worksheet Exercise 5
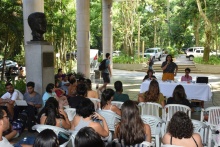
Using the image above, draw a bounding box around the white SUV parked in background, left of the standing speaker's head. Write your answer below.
[144,48,163,61]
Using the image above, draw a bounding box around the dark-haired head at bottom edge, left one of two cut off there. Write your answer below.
[33,129,59,147]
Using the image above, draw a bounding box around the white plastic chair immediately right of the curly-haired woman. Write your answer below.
[192,119,209,145]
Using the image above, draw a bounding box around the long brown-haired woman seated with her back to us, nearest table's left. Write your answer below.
[138,80,165,107]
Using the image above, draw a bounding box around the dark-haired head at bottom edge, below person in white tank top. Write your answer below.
[74,127,105,147]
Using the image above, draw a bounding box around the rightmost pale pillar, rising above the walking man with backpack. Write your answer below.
[102,0,113,59]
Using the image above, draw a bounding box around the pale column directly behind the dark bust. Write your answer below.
[23,0,44,45]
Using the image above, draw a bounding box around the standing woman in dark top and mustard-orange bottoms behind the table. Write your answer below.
[161,55,178,81]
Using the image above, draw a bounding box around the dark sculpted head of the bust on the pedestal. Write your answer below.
[28,12,47,41]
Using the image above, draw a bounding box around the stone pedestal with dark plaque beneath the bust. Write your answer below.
[25,41,54,95]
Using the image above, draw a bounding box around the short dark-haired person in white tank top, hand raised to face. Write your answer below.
[71,99,109,137]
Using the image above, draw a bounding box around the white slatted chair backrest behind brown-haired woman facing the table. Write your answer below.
[138,102,163,117]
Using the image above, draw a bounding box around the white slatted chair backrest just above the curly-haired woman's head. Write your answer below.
[162,104,191,122]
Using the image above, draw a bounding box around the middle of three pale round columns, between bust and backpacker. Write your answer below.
[76,0,90,78]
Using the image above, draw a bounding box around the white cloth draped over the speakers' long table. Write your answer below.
[140,80,212,101]
